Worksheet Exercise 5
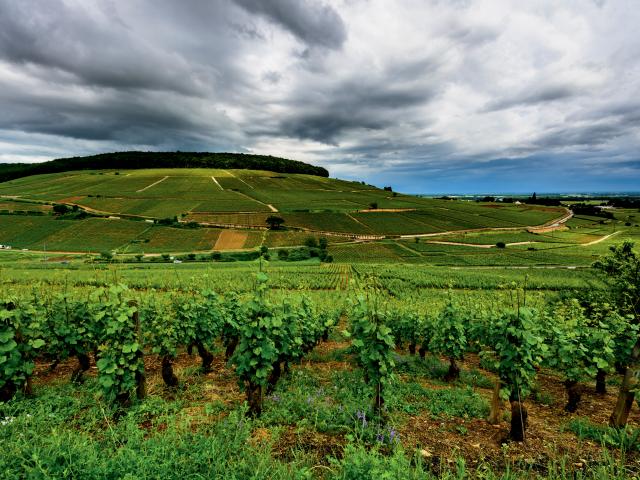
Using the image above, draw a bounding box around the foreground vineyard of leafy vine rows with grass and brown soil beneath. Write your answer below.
[0,243,640,478]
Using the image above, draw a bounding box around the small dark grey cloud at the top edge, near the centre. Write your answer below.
[233,0,347,48]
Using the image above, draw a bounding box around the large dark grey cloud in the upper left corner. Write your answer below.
[0,0,214,94]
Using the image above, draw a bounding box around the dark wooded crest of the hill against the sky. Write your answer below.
[0,151,329,182]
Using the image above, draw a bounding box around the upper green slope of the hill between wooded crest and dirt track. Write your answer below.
[0,169,562,225]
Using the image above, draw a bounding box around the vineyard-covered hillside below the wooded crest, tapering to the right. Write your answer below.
[0,168,566,261]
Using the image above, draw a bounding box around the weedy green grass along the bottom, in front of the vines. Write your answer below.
[0,349,637,479]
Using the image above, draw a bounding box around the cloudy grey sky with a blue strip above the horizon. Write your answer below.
[0,0,640,193]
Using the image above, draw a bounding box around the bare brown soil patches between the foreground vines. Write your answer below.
[34,341,640,475]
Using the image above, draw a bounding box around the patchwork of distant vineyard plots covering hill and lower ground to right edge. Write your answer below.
[0,168,640,267]
